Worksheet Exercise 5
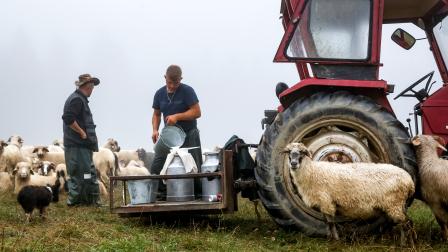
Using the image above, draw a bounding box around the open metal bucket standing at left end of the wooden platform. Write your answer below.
[128,179,159,205]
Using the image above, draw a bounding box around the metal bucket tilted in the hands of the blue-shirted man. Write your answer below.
[154,126,186,155]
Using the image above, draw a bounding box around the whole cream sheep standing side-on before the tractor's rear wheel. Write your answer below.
[284,143,415,244]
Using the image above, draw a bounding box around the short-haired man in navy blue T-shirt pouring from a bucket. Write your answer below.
[150,65,202,200]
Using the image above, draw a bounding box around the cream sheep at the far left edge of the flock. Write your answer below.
[0,136,24,173]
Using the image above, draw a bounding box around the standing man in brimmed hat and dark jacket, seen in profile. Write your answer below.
[62,74,100,206]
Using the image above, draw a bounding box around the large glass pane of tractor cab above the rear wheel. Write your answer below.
[286,0,372,60]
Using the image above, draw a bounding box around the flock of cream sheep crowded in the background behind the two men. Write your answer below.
[0,135,154,207]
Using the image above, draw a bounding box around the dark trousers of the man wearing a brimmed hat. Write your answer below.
[65,147,99,205]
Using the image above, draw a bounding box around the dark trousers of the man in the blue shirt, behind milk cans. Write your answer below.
[150,129,202,195]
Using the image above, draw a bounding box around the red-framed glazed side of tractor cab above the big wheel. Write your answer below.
[275,0,382,80]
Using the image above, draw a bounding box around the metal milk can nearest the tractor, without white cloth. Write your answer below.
[201,152,221,202]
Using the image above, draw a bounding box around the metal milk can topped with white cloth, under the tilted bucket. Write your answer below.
[166,154,194,201]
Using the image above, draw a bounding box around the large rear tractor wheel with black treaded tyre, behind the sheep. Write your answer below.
[255,91,416,236]
